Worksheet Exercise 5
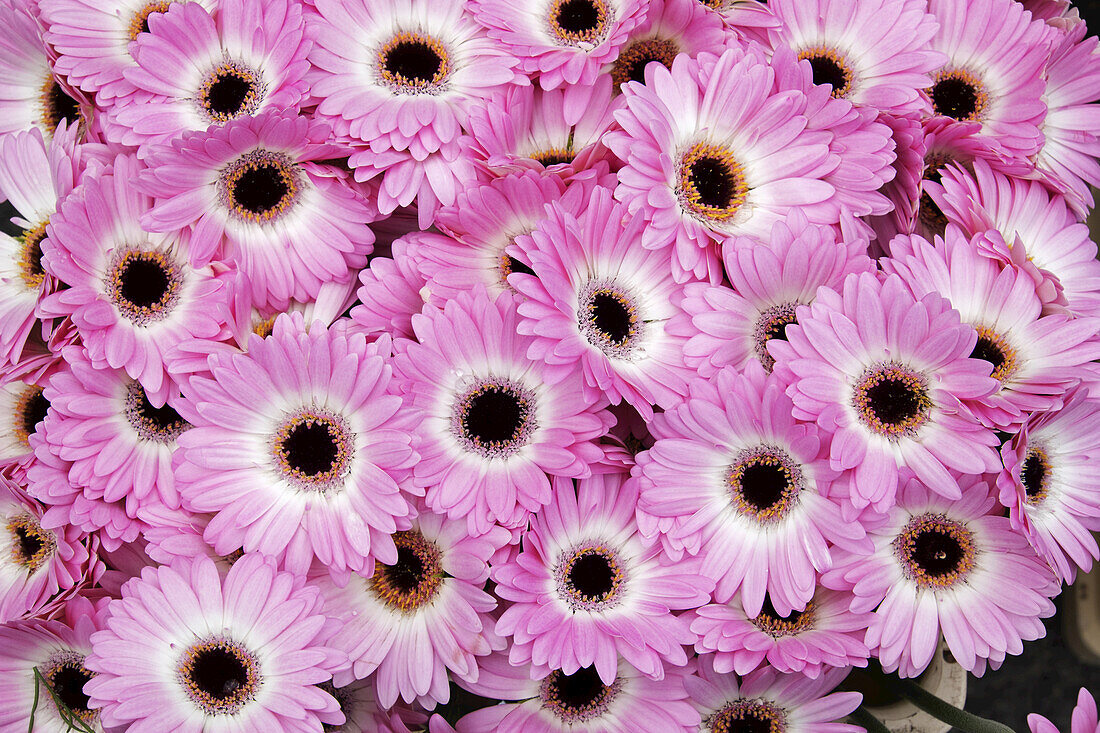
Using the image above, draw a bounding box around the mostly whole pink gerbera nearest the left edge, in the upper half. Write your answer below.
[40,155,228,405]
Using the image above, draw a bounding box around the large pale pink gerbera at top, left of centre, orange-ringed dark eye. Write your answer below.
[309,0,527,157]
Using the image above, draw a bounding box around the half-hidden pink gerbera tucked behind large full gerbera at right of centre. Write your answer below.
[672,211,875,376]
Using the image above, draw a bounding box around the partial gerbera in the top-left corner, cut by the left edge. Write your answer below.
[0,0,94,138]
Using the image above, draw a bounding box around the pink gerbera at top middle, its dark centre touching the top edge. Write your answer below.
[470,0,649,89]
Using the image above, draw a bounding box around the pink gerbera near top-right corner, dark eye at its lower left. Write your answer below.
[925,0,1058,158]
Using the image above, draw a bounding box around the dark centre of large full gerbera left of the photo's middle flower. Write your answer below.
[275,411,352,491]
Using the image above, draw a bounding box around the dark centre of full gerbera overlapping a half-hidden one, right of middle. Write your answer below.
[854,364,932,439]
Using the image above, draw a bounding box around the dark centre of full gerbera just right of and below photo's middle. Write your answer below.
[726,446,802,523]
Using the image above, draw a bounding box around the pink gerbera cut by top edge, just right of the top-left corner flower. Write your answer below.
[39,0,216,106]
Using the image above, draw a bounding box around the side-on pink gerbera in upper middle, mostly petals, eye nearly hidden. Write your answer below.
[470,74,615,178]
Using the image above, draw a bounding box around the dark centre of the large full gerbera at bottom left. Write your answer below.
[178,638,261,714]
